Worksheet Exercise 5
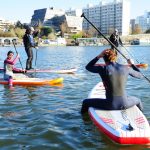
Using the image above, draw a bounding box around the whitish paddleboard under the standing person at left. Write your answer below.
[0,68,77,74]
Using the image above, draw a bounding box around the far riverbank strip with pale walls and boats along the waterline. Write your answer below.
[0,34,150,47]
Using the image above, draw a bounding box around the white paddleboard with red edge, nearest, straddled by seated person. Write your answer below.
[88,82,150,145]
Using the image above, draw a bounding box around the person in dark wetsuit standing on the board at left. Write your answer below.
[23,27,38,70]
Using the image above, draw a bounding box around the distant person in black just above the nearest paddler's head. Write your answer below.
[109,29,123,50]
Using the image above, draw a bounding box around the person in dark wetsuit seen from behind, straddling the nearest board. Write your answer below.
[81,49,143,113]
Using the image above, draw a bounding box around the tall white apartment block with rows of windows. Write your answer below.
[83,0,130,35]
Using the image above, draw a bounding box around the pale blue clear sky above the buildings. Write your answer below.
[0,0,150,23]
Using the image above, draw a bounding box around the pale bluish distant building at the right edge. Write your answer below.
[135,12,150,33]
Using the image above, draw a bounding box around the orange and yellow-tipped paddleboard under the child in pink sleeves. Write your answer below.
[0,78,64,86]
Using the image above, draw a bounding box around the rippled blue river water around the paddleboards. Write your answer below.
[0,46,150,150]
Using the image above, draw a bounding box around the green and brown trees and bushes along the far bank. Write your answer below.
[0,21,150,40]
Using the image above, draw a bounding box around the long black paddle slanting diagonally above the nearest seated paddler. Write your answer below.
[81,13,150,83]
